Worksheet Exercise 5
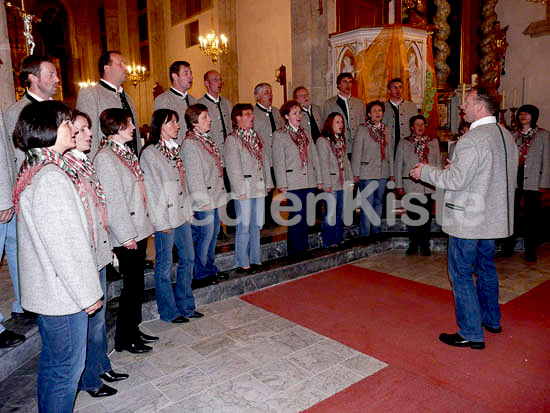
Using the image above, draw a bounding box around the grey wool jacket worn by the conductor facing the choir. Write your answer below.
[421,123,518,239]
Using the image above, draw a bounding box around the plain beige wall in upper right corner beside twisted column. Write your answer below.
[496,0,550,129]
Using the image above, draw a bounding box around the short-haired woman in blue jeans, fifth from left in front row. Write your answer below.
[181,103,227,286]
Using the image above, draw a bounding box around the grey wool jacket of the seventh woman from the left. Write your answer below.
[273,128,323,190]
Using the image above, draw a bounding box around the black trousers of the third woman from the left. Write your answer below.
[113,238,147,346]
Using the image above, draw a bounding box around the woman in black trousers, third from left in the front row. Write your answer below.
[94,108,158,353]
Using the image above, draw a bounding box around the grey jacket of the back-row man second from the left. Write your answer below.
[76,83,141,159]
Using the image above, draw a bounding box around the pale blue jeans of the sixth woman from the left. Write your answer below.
[235,198,265,268]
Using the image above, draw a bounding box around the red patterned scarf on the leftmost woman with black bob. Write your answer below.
[12,148,95,243]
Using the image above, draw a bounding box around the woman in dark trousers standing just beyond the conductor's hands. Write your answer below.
[395,115,441,256]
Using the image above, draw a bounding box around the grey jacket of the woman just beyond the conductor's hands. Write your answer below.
[395,138,441,194]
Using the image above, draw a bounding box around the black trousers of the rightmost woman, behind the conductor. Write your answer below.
[502,189,542,254]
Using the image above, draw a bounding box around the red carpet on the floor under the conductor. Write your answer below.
[243,265,550,412]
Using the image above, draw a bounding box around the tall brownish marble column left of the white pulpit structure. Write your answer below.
[288,0,328,105]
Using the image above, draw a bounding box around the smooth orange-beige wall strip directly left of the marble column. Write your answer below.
[237,0,292,107]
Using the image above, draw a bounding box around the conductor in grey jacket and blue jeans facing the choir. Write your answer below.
[410,88,518,350]
